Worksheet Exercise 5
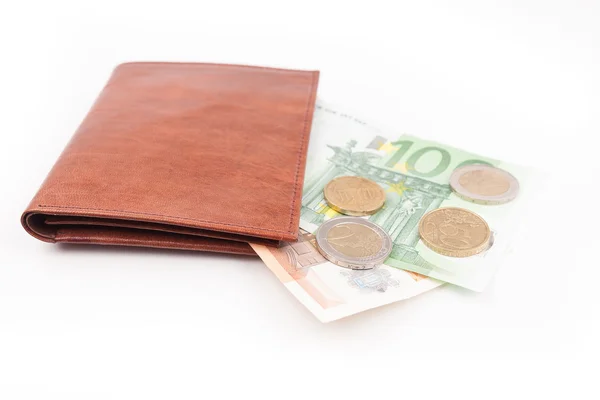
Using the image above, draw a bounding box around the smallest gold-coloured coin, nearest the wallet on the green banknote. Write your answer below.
[323,176,385,217]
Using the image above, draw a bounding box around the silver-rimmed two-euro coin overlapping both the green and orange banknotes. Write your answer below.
[315,217,392,269]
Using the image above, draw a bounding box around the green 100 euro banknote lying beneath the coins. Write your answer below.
[300,101,532,291]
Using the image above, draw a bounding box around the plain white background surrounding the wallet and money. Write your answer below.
[0,0,600,400]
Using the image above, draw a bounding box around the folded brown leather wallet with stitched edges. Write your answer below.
[21,62,319,254]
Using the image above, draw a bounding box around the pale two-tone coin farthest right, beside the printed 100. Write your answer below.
[450,164,519,205]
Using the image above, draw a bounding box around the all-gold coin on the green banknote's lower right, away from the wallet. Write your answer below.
[419,207,491,257]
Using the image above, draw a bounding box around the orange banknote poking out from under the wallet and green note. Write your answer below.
[251,231,443,322]
